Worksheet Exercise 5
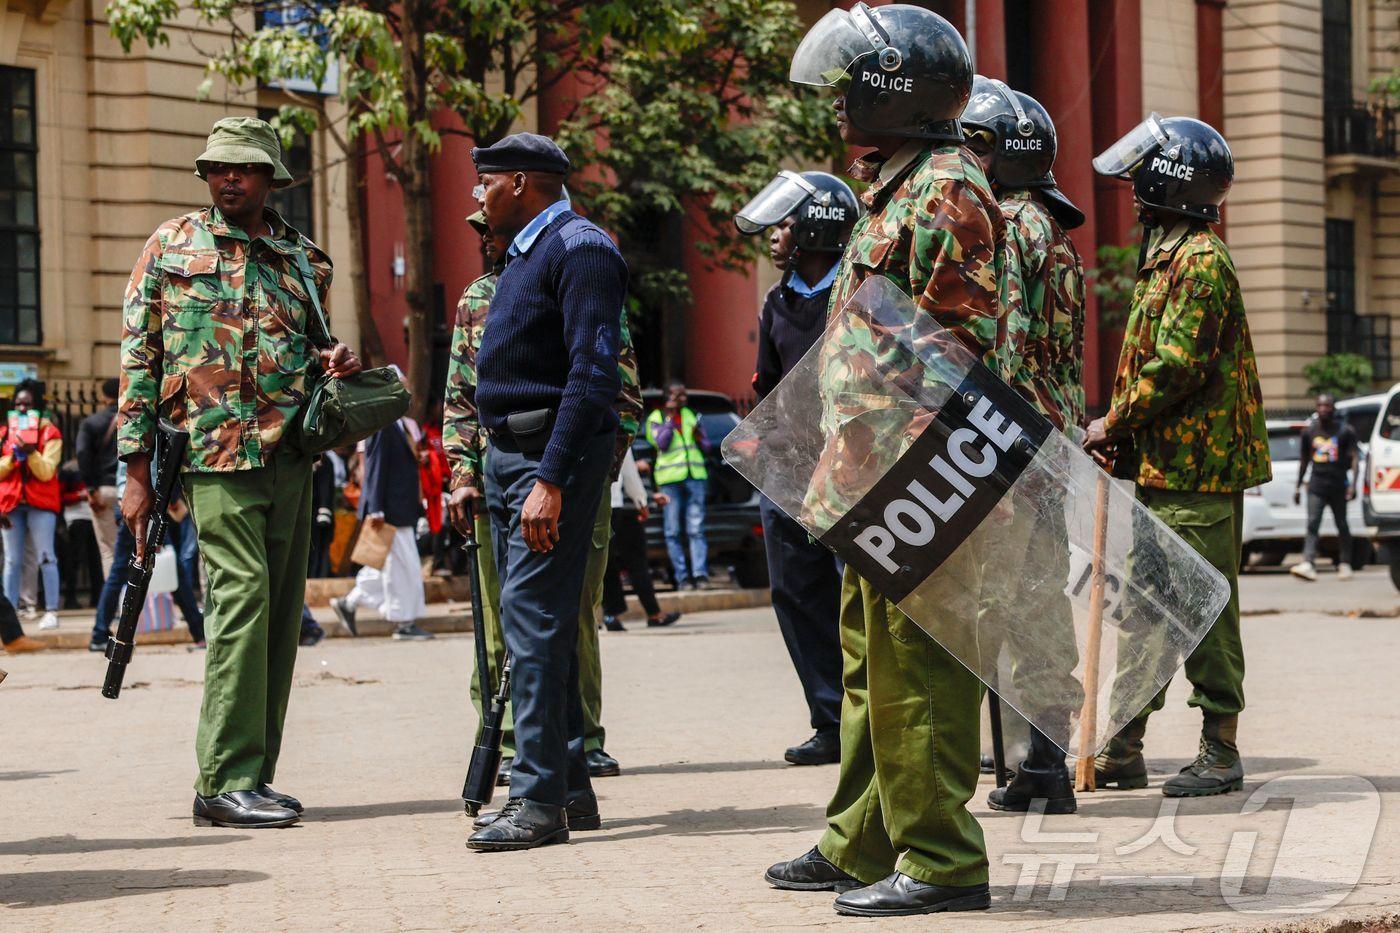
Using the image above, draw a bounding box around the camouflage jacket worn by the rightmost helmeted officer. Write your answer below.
[1105,221,1273,493]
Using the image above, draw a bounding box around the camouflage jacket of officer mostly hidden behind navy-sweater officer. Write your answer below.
[442,270,641,489]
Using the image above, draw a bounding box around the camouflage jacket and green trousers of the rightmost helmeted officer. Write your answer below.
[1103,220,1273,759]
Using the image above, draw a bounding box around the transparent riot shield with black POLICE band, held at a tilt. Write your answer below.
[724,276,1229,755]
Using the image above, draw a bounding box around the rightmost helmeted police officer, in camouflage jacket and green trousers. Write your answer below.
[1085,113,1273,797]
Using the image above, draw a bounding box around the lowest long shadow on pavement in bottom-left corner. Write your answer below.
[0,869,272,908]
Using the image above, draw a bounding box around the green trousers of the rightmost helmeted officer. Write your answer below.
[1134,486,1245,726]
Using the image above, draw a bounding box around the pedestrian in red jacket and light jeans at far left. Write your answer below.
[0,385,63,630]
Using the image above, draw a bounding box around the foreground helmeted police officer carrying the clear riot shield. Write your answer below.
[766,3,1005,916]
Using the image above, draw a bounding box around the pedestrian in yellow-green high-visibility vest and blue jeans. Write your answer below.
[647,380,710,590]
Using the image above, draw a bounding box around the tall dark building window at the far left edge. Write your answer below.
[0,67,43,345]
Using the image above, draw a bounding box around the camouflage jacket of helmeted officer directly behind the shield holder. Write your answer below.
[1001,189,1084,430]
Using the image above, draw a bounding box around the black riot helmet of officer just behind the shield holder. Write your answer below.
[962,74,1056,188]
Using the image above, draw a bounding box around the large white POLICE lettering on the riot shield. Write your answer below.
[855,398,1021,573]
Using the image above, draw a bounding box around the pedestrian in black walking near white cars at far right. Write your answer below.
[1289,392,1361,580]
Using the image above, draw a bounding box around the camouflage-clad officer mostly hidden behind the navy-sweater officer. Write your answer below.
[445,210,641,801]
